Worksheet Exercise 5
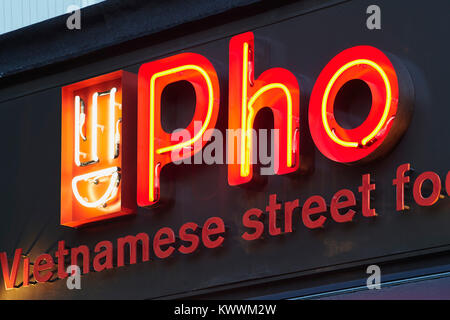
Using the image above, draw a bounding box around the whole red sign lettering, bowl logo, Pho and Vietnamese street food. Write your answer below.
[0,32,450,289]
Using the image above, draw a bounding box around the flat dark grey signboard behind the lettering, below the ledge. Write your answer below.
[0,0,450,299]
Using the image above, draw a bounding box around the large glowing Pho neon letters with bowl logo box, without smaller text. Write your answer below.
[61,32,413,227]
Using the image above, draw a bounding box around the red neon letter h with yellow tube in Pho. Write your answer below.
[228,32,300,185]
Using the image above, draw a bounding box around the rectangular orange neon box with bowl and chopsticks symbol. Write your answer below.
[61,71,137,227]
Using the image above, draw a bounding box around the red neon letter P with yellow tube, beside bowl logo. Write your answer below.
[137,53,219,207]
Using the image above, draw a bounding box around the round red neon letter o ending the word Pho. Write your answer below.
[309,46,413,163]
